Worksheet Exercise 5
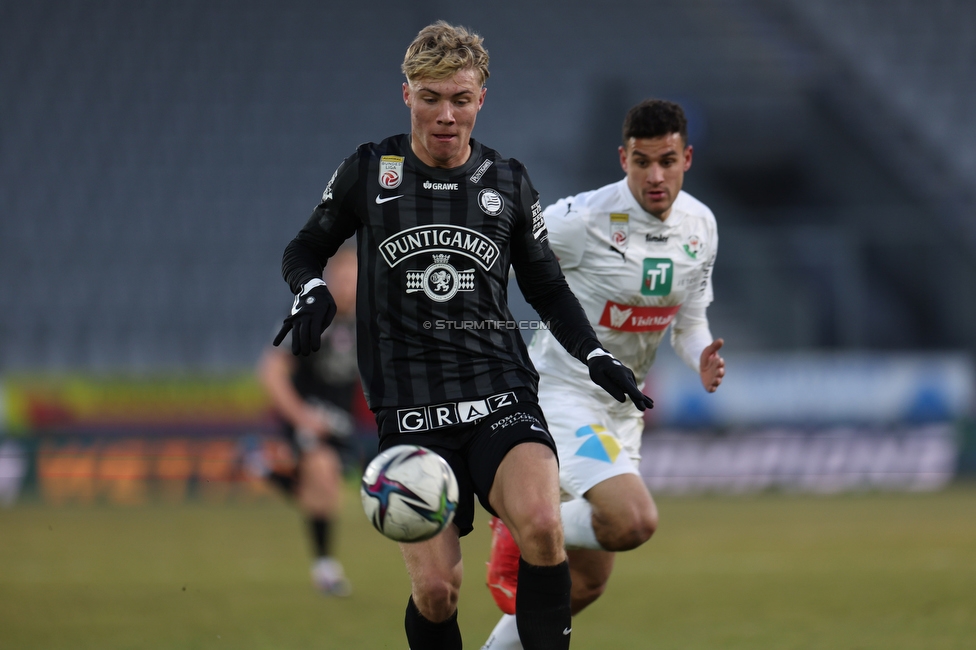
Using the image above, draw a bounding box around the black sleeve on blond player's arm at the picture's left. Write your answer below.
[281,154,359,294]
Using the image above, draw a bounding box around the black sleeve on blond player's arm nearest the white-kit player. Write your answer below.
[512,165,603,363]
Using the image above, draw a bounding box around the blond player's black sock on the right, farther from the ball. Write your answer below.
[515,558,573,650]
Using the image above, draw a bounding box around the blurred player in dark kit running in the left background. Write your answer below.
[258,248,366,596]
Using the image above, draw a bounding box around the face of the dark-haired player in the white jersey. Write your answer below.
[620,133,691,221]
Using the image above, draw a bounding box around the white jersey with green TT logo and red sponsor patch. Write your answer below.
[529,178,718,384]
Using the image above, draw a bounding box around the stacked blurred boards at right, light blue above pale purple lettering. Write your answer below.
[641,353,976,493]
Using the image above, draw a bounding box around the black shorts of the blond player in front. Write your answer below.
[376,402,556,537]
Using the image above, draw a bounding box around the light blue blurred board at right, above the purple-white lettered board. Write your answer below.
[646,352,976,427]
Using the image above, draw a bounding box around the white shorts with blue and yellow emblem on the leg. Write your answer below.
[539,375,644,500]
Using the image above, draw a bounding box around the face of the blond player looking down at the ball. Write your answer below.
[403,68,486,169]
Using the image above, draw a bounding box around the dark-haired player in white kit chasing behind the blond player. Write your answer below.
[483,100,725,650]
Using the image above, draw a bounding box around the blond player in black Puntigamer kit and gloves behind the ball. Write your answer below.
[276,22,651,650]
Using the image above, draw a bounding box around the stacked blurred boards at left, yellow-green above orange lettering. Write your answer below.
[0,374,274,505]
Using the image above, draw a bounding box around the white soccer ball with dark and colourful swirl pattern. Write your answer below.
[359,445,458,542]
